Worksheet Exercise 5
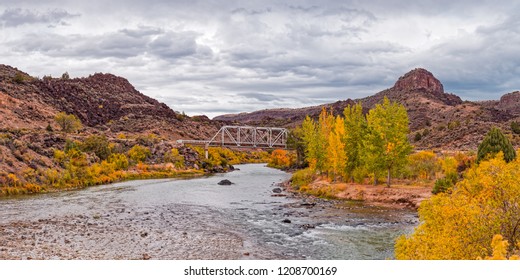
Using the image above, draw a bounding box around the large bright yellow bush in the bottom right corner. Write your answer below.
[395,152,520,259]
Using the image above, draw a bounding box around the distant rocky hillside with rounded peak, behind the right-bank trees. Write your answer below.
[215,69,520,150]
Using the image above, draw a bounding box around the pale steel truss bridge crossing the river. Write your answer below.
[177,125,287,158]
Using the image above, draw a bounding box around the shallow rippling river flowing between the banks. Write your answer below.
[0,164,417,259]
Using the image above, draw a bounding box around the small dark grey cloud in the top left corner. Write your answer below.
[0,8,79,27]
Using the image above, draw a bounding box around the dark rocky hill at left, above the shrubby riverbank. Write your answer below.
[0,65,219,140]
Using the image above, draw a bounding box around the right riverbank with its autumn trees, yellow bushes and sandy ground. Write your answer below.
[278,95,520,259]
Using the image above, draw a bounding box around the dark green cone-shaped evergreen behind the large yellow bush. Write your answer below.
[477,127,516,163]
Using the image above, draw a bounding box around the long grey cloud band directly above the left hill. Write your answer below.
[10,26,211,60]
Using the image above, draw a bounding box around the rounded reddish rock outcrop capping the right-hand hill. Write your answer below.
[394,68,444,93]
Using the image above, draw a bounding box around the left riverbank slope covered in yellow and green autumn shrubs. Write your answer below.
[0,124,269,196]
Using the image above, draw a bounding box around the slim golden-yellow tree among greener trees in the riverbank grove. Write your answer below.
[327,116,347,178]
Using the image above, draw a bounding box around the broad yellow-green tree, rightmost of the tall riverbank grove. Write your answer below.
[363,96,412,187]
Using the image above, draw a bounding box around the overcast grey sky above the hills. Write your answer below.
[0,0,520,117]
